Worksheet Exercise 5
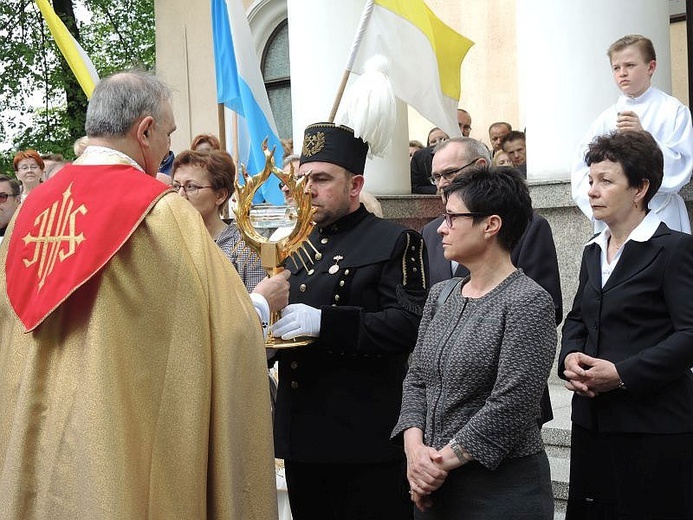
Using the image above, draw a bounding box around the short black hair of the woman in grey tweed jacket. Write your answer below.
[443,165,532,251]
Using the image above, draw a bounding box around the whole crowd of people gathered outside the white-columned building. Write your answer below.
[0,31,693,520]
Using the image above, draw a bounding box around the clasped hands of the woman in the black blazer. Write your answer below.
[563,352,621,397]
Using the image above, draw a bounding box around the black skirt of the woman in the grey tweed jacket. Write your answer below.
[414,451,553,520]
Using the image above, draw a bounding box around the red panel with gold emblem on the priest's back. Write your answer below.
[5,164,169,332]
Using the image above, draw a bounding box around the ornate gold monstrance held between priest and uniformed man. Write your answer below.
[234,141,315,348]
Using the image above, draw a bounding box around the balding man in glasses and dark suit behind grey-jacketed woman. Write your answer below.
[422,137,563,424]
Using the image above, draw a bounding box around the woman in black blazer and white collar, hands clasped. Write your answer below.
[558,132,693,520]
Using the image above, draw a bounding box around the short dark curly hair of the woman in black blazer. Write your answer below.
[585,131,664,208]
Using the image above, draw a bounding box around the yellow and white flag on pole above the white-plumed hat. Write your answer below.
[350,0,474,136]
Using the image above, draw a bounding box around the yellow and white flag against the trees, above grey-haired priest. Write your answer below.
[36,0,99,99]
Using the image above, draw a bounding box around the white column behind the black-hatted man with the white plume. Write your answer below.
[287,0,410,195]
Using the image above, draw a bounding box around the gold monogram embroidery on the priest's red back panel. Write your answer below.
[23,184,87,291]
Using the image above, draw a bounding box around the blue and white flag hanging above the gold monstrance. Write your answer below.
[212,0,284,204]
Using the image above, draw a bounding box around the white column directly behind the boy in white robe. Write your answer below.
[517,0,672,181]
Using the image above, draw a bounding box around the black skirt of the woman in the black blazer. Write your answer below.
[566,424,693,520]
